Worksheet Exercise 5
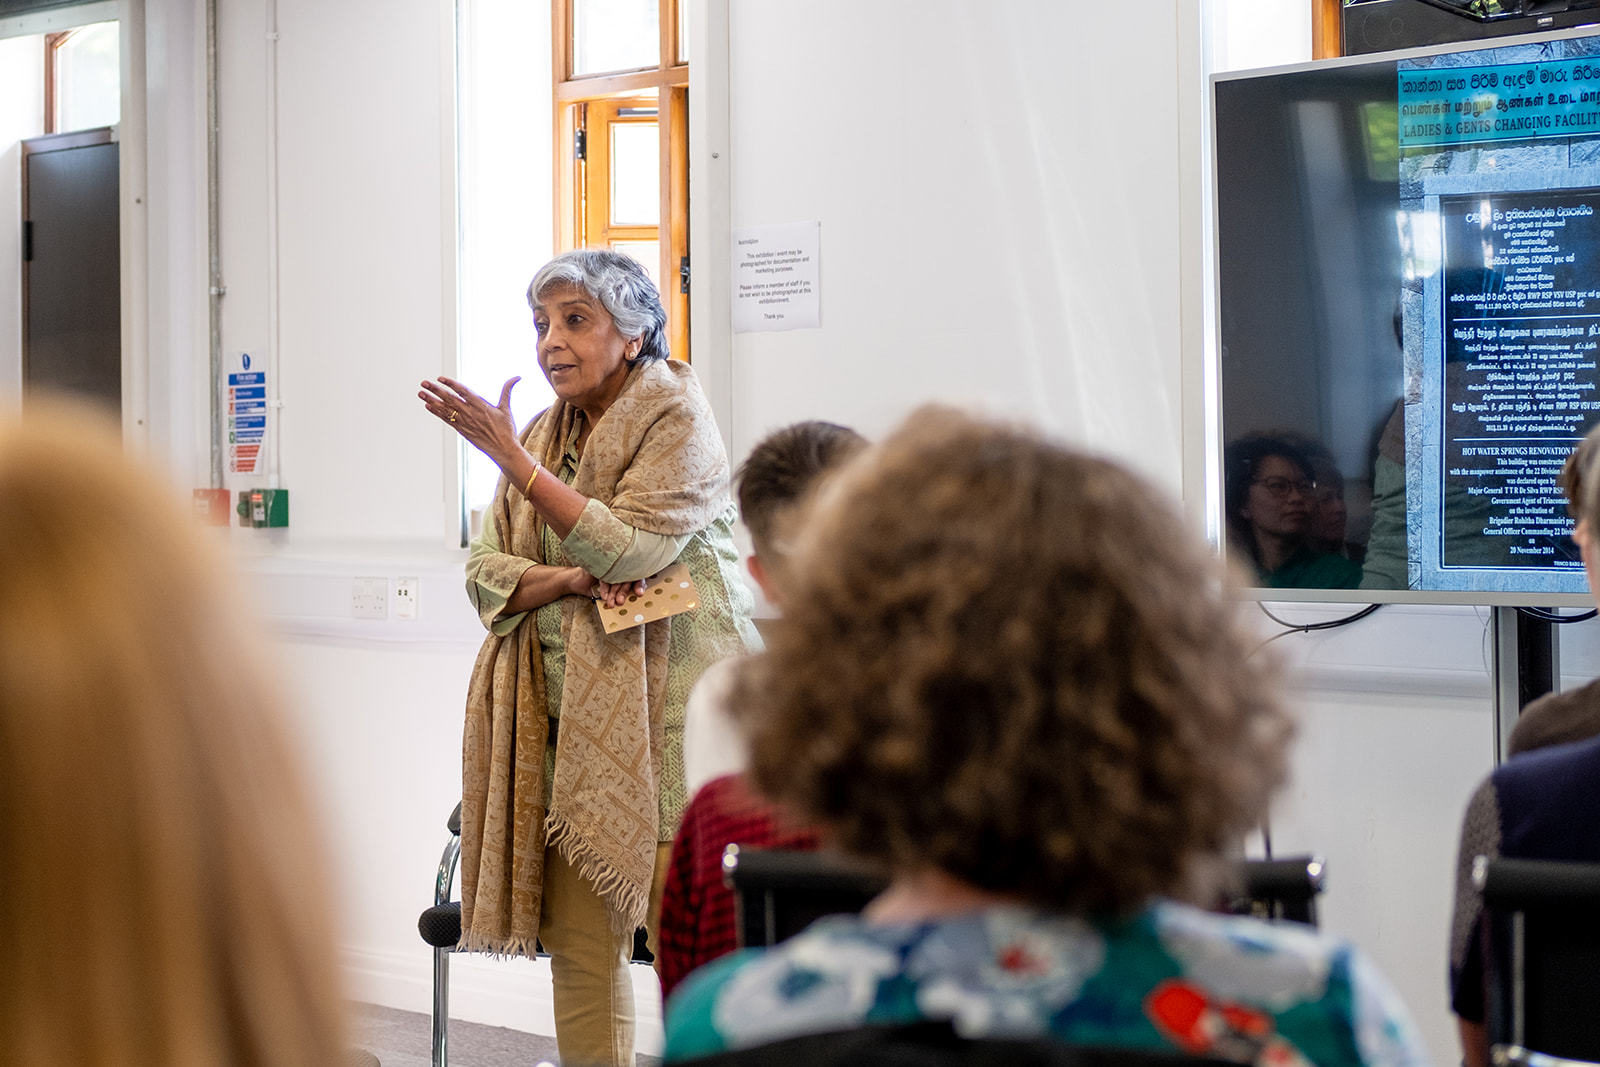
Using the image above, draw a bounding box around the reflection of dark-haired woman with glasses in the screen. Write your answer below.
[1224,434,1362,589]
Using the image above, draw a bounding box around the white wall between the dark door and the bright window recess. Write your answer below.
[219,0,454,545]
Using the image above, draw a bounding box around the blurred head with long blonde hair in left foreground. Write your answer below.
[0,402,344,1067]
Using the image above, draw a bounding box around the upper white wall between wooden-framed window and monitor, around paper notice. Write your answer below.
[726,0,1181,490]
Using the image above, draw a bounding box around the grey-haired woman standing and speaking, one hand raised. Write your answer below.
[419,250,758,1064]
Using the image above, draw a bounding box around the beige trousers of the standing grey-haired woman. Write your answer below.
[539,845,672,1067]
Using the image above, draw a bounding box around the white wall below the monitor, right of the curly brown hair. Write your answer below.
[1262,605,1494,1062]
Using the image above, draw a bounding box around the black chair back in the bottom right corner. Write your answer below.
[1472,856,1600,1061]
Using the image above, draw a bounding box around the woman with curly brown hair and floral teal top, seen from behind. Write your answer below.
[666,410,1426,1067]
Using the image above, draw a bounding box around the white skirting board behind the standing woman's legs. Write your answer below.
[344,945,662,1056]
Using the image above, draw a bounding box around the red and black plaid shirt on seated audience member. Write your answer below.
[656,774,818,997]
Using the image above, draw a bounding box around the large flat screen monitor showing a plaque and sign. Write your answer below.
[1208,30,1600,606]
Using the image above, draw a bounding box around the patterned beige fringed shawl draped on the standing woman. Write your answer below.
[461,360,728,957]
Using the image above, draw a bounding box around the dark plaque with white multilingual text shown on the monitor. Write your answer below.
[1426,189,1600,581]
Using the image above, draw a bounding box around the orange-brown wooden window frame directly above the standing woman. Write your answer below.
[550,0,690,360]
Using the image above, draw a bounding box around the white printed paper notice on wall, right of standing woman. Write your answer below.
[733,222,822,333]
